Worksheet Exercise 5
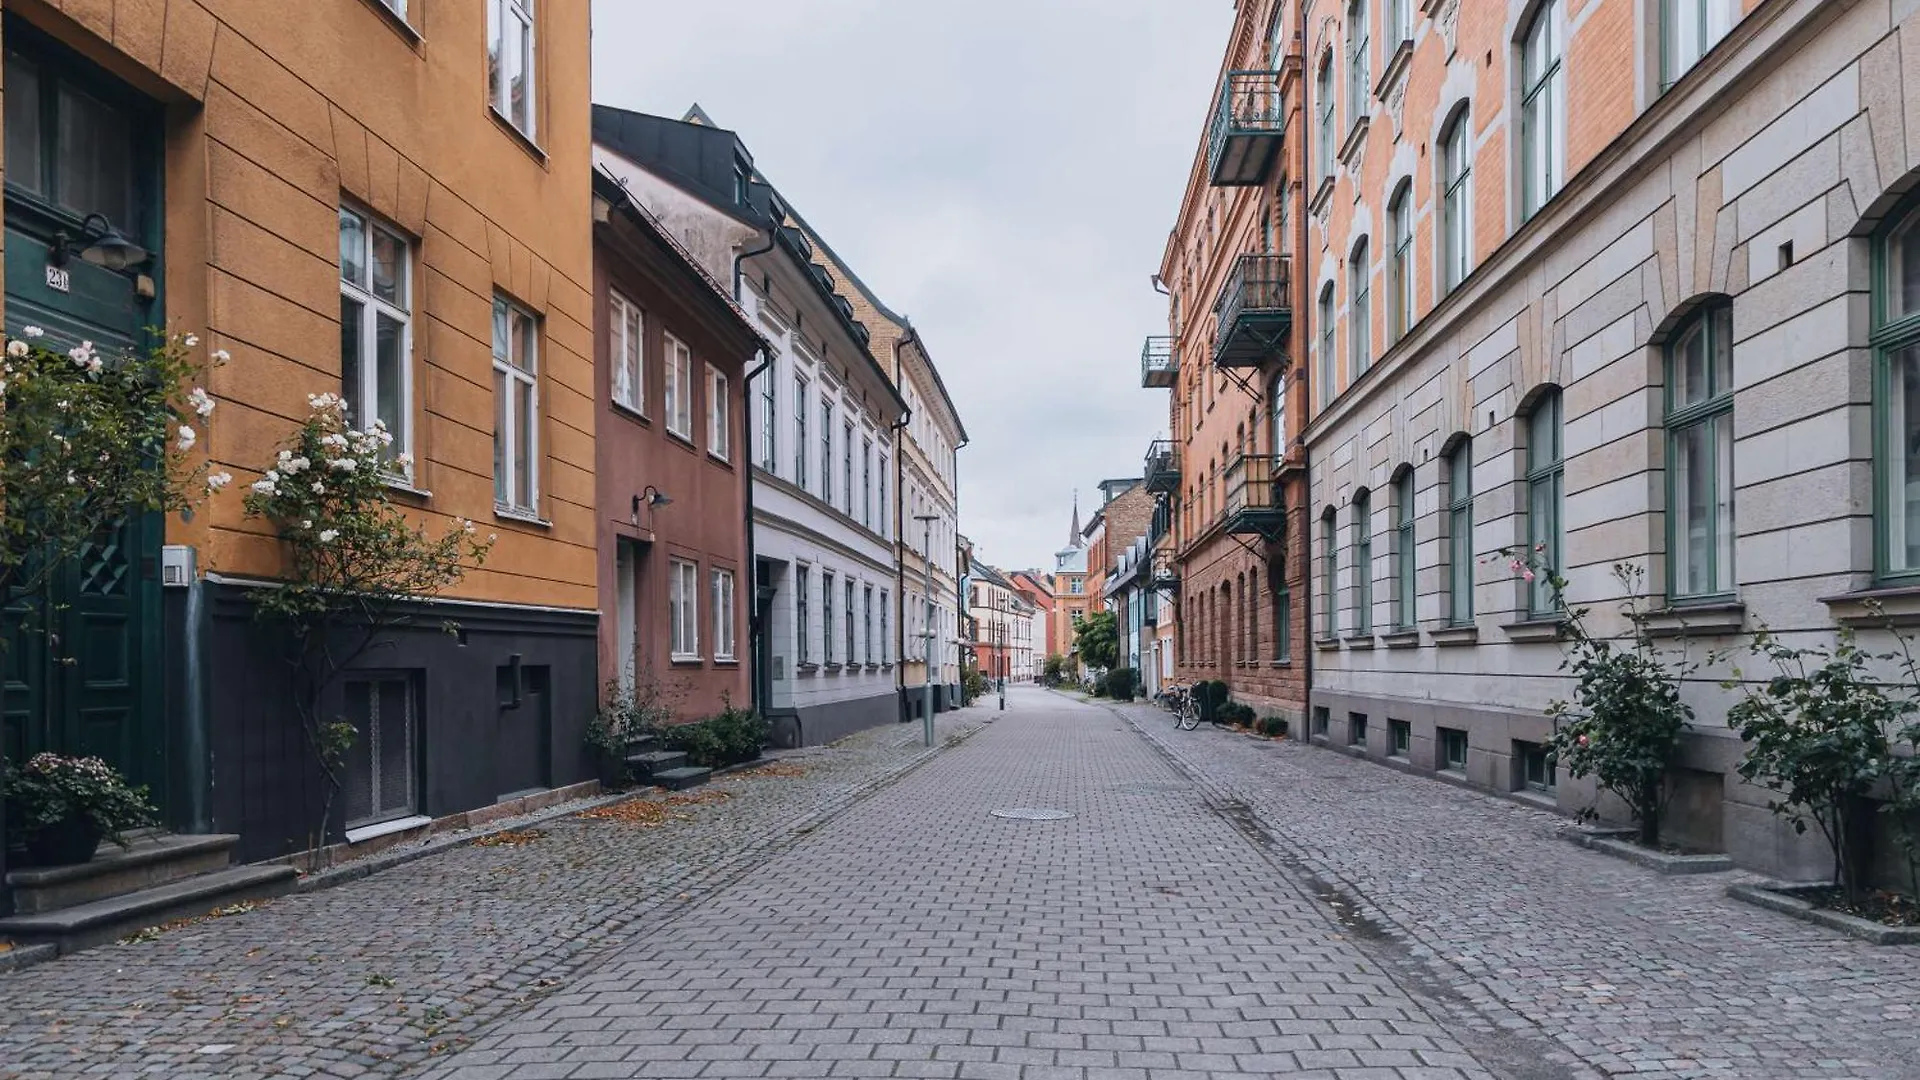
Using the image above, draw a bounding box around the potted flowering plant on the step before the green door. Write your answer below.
[4,753,157,867]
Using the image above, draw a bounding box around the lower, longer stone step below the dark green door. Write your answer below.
[0,863,298,953]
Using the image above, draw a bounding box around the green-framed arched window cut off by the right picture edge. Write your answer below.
[1874,204,1920,577]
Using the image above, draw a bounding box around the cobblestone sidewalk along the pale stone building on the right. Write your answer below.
[1123,691,1920,1080]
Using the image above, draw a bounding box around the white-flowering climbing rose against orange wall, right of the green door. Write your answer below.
[246,394,495,849]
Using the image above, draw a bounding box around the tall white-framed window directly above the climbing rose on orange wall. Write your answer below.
[340,206,413,457]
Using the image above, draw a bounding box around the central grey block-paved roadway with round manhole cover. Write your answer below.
[424,688,1565,1080]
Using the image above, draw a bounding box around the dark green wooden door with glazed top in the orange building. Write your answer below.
[0,21,167,805]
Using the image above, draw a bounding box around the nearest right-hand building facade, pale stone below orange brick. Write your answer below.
[1296,0,1920,876]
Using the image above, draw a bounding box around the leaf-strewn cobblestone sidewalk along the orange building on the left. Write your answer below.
[0,707,989,1080]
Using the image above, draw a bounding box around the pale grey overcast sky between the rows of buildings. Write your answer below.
[593,0,1233,569]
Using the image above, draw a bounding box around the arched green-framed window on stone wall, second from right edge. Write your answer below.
[1667,304,1734,600]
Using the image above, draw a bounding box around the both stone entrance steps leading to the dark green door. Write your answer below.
[0,832,298,953]
